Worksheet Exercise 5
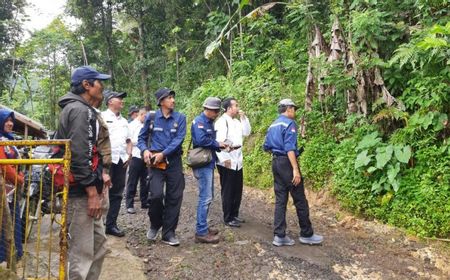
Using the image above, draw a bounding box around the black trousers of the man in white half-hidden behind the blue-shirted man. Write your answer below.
[126,157,148,208]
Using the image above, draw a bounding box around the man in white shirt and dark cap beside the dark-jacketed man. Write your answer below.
[102,91,132,237]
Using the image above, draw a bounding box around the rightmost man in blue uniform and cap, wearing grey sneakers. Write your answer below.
[263,99,323,246]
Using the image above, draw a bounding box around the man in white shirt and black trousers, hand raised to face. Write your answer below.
[214,97,251,227]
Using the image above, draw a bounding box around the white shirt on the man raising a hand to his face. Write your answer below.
[214,114,252,170]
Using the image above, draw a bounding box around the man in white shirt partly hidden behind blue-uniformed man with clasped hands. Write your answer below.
[126,107,148,214]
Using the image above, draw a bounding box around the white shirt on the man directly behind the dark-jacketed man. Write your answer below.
[102,109,129,164]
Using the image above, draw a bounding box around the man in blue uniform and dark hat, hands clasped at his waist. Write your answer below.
[137,88,186,246]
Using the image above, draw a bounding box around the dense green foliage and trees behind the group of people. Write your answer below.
[0,0,450,237]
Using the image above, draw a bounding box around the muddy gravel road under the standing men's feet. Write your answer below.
[102,174,450,280]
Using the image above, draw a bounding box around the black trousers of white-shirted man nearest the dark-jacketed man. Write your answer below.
[106,160,127,228]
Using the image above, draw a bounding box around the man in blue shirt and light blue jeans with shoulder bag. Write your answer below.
[191,97,227,243]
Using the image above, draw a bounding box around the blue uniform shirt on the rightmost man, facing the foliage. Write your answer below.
[263,115,299,157]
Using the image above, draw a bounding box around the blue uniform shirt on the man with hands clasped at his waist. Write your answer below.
[137,110,186,157]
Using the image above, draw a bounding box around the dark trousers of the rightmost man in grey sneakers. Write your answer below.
[272,156,314,237]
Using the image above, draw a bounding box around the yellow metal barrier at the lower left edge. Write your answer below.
[0,140,71,280]
